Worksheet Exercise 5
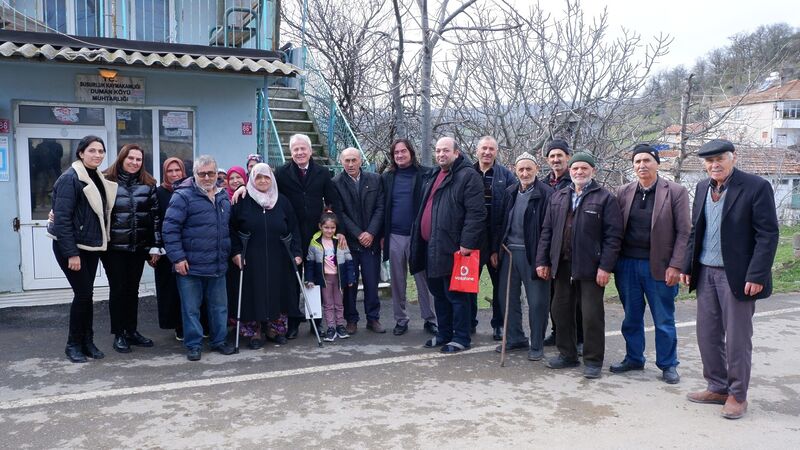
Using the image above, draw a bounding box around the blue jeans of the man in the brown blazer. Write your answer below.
[614,257,678,370]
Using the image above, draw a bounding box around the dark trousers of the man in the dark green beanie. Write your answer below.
[552,260,606,366]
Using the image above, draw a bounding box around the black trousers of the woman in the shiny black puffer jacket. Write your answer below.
[103,250,147,334]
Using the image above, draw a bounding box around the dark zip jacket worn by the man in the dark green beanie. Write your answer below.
[536,180,622,280]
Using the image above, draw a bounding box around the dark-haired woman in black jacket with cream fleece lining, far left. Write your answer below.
[48,136,117,363]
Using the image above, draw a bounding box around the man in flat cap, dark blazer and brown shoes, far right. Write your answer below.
[681,139,778,419]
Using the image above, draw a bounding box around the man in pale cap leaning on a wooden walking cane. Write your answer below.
[494,152,553,361]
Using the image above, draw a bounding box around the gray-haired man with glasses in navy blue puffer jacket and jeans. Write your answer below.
[162,155,233,361]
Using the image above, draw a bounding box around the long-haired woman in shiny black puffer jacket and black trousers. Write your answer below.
[102,144,162,353]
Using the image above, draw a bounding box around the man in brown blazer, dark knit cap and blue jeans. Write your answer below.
[611,144,691,384]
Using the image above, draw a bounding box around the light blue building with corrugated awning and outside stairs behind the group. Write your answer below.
[0,0,357,306]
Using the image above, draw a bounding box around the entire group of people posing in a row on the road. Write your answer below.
[50,134,778,418]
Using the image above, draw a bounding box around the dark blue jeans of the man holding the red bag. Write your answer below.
[428,275,472,347]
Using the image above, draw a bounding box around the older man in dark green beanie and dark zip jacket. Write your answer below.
[536,153,622,378]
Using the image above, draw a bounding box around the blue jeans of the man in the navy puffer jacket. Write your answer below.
[178,275,228,350]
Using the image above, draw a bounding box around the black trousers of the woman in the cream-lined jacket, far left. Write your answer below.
[53,241,100,344]
